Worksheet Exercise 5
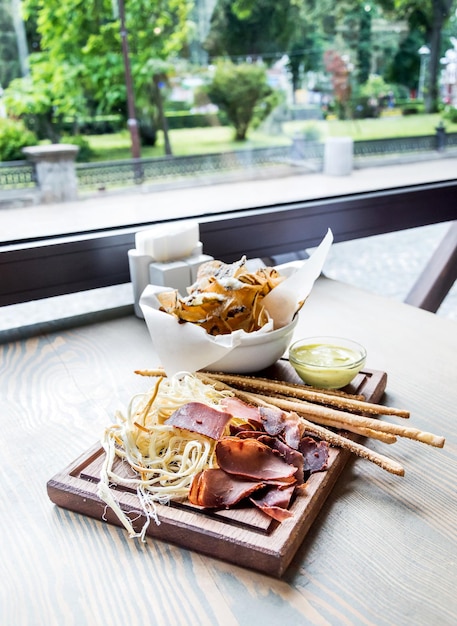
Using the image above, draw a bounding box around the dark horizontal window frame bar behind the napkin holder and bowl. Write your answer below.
[0,180,457,306]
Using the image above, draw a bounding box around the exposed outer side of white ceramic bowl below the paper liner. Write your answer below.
[205,315,298,374]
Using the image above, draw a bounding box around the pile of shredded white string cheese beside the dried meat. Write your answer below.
[98,373,233,541]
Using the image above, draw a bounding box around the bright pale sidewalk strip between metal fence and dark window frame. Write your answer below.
[0,158,457,242]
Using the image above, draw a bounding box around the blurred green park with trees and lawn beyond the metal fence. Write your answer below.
[0,0,457,171]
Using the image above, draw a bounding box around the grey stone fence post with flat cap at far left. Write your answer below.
[23,143,79,203]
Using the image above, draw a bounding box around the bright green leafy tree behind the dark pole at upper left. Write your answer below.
[10,0,192,145]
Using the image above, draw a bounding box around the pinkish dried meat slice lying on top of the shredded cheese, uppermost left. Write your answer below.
[166,402,232,441]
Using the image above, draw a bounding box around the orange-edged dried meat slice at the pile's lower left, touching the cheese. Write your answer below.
[189,468,264,509]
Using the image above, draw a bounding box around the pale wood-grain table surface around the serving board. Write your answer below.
[0,278,457,626]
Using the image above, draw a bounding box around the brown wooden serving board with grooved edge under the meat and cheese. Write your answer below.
[47,361,387,577]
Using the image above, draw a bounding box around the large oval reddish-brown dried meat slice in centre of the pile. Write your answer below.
[216,437,297,483]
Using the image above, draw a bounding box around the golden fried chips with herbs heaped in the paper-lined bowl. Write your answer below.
[157,257,284,335]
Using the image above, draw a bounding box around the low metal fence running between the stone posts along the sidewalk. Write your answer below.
[0,129,457,191]
